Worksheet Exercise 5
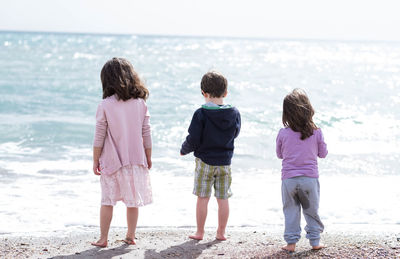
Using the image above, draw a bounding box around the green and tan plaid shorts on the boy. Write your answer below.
[193,158,232,199]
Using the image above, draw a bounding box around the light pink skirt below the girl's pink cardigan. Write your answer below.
[100,165,153,207]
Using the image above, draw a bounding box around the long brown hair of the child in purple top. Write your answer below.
[282,88,317,140]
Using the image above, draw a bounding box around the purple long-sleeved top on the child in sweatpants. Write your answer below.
[276,128,328,180]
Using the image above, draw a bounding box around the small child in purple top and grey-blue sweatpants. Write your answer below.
[276,89,328,252]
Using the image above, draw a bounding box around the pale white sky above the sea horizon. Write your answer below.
[0,0,400,41]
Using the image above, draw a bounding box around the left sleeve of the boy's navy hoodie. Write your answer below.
[181,110,204,155]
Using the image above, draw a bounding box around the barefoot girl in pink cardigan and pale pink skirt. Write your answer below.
[92,58,152,247]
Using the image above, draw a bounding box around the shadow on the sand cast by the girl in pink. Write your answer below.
[50,244,132,259]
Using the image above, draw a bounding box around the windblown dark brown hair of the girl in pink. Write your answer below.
[100,58,149,101]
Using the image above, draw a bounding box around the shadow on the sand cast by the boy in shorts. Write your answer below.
[144,240,221,259]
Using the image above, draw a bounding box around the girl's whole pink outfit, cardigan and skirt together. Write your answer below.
[93,95,152,207]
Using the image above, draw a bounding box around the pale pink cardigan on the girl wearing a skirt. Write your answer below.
[93,95,152,177]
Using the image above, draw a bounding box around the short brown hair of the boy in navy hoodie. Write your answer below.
[201,71,228,98]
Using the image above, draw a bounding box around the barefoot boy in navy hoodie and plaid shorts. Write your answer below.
[181,72,240,241]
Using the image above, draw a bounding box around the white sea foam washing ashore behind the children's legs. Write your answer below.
[0,161,400,239]
